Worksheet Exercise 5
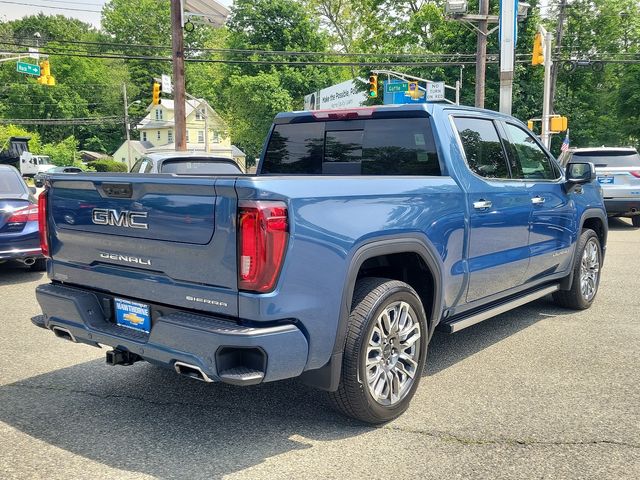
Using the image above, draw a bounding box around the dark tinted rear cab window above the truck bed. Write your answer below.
[260,118,441,176]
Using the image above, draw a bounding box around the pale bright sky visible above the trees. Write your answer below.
[0,0,233,28]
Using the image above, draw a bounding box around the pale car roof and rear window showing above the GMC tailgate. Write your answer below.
[131,152,244,175]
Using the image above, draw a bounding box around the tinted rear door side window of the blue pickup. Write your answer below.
[454,117,509,178]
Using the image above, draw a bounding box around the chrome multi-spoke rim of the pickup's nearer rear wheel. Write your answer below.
[365,301,422,406]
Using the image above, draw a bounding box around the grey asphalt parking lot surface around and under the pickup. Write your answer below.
[0,220,640,479]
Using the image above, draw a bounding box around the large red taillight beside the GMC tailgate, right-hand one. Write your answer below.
[238,201,289,293]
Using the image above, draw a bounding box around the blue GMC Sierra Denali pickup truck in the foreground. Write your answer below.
[33,104,607,423]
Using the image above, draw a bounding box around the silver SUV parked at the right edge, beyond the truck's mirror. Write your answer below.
[558,147,640,227]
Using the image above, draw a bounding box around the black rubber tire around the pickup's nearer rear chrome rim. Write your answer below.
[329,278,428,424]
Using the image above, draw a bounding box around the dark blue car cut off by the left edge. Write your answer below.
[0,165,46,270]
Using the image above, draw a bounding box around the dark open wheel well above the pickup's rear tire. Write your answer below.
[357,252,435,325]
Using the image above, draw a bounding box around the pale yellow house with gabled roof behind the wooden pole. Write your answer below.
[113,99,246,170]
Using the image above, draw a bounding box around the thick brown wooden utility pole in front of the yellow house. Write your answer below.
[171,0,187,152]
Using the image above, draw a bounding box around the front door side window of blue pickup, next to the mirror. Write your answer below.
[504,123,558,180]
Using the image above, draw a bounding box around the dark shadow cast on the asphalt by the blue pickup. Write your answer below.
[0,299,571,479]
